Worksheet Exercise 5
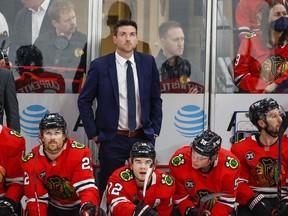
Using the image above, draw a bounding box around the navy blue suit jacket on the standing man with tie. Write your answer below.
[78,52,162,142]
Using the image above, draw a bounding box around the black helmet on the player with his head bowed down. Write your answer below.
[191,130,222,157]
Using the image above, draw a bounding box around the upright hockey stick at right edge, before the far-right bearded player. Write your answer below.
[276,110,288,215]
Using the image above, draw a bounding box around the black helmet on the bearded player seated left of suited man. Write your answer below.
[39,113,67,131]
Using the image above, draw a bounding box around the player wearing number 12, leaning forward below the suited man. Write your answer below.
[106,142,175,216]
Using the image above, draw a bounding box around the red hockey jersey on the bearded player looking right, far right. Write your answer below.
[231,135,288,205]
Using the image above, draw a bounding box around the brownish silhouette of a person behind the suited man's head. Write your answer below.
[101,1,151,56]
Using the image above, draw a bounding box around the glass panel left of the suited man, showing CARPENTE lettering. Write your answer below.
[3,0,89,93]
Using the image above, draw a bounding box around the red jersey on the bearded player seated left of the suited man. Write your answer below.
[22,139,100,216]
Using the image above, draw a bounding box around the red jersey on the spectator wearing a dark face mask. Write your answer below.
[234,32,288,93]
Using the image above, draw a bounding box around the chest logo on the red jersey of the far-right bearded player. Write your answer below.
[253,157,285,187]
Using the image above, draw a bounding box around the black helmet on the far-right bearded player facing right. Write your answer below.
[249,98,279,128]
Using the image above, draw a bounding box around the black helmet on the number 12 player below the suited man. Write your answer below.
[130,142,156,159]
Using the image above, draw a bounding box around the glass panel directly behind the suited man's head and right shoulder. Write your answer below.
[101,0,206,93]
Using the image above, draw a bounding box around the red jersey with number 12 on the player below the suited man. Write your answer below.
[106,165,175,216]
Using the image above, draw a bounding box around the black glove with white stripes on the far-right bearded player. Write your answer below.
[247,194,271,216]
